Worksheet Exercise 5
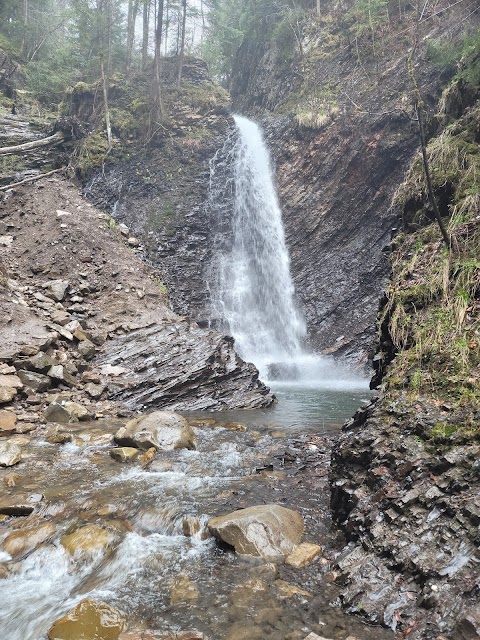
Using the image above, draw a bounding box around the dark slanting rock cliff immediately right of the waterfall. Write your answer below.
[232,3,476,365]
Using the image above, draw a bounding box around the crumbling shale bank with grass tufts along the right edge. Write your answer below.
[330,67,480,640]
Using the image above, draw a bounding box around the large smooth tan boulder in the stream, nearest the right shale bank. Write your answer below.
[208,504,304,561]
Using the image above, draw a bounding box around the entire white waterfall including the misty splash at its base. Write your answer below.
[211,115,368,399]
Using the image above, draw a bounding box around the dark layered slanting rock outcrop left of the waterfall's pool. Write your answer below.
[99,319,274,410]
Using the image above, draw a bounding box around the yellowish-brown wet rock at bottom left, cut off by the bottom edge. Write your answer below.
[48,598,126,640]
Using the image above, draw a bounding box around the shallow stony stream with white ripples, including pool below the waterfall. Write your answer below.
[0,382,392,640]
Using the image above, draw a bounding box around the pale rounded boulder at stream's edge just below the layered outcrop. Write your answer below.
[115,411,195,451]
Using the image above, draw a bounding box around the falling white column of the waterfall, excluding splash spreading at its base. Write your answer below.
[213,116,306,375]
